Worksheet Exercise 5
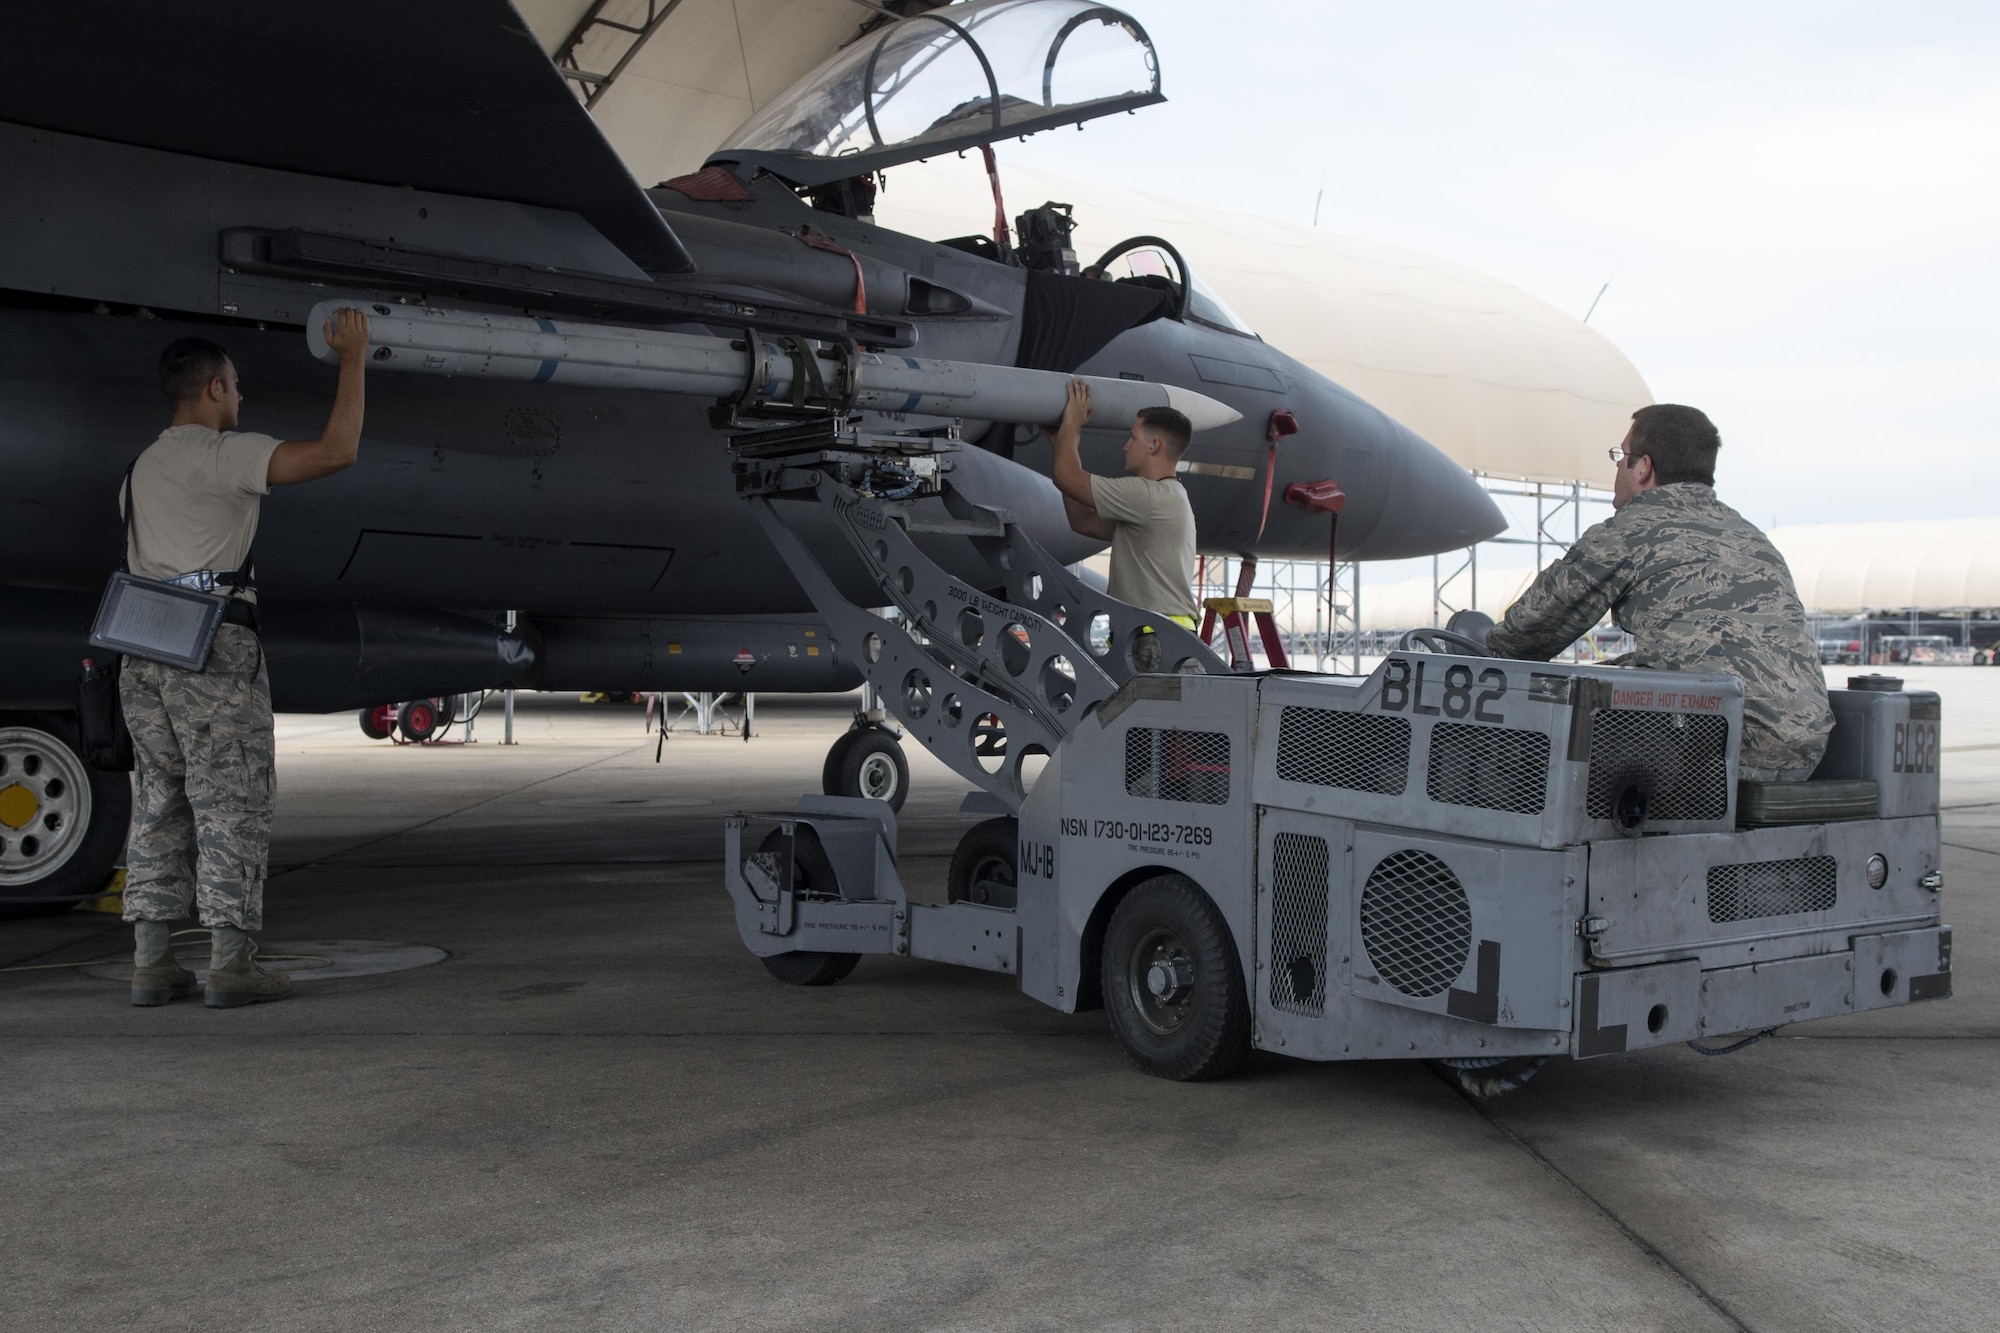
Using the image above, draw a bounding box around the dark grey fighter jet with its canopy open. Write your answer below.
[0,0,1504,905]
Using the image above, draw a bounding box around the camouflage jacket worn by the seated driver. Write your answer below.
[1486,482,1834,773]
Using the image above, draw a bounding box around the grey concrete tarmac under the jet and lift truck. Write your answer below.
[0,669,2000,1333]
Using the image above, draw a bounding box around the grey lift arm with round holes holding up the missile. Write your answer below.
[730,420,1228,813]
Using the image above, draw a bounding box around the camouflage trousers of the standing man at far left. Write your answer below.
[118,624,276,931]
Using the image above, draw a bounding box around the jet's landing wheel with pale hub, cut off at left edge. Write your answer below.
[0,713,132,917]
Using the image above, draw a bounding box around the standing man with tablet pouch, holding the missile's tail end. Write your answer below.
[118,310,368,1009]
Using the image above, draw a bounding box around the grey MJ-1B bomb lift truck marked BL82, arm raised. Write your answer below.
[726,422,1952,1095]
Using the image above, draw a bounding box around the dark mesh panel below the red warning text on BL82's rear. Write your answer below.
[1584,709,1730,821]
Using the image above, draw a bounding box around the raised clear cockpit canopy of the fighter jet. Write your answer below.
[714,0,1166,186]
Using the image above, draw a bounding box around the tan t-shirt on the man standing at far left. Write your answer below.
[118,426,278,578]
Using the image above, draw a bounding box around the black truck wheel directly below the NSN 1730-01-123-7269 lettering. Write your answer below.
[1100,875,1250,1081]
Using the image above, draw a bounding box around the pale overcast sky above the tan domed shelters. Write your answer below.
[1002,0,2000,524]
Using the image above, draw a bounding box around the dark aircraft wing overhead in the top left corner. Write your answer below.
[0,0,694,274]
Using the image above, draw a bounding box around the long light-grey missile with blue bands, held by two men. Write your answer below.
[306,300,1242,430]
